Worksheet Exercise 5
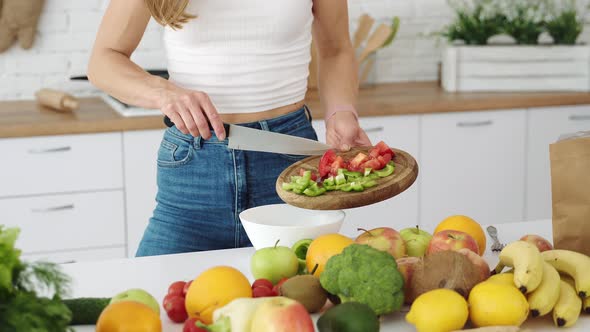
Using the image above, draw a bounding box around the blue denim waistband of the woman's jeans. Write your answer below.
[167,105,312,146]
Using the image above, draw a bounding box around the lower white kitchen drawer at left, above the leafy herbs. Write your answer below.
[0,190,125,253]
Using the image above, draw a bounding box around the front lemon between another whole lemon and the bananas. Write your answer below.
[468,281,529,327]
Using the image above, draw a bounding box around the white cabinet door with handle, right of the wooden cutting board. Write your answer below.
[419,110,526,230]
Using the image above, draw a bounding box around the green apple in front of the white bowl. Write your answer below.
[250,241,299,285]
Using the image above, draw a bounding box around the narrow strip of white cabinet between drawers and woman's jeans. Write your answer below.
[123,130,164,257]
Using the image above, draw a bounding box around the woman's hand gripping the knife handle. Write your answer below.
[160,87,225,141]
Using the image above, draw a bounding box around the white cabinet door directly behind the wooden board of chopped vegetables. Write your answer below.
[314,116,420,236]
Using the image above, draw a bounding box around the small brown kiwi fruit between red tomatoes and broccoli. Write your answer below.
[279,274,328,313]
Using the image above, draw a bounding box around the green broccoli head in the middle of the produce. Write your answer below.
[320,244,404,315]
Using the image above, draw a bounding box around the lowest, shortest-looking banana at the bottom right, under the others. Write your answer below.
[553,278,582,327]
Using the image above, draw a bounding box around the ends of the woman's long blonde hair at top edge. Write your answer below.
[144,0,196,30]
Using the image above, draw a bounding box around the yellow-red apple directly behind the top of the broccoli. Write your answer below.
[354,227,406,259]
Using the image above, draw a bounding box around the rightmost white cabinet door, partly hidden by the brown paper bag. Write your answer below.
[525,105,590,220]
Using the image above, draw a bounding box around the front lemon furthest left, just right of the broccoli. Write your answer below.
[406,288,469,332]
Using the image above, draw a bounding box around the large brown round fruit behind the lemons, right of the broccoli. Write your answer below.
[408,250,481,302]
